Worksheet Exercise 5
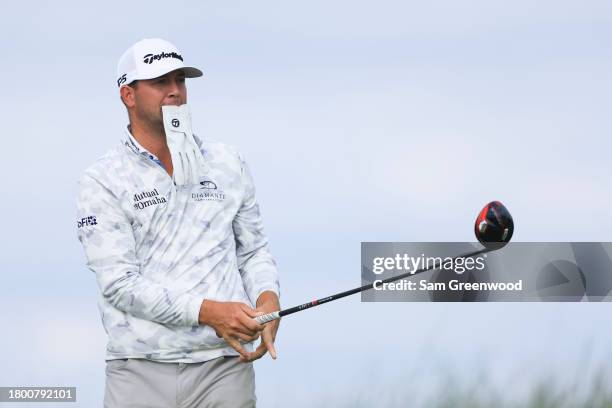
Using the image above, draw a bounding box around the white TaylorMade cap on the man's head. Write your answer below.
[117,38,202,88]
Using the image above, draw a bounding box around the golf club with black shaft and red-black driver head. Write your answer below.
[254,201,514,324]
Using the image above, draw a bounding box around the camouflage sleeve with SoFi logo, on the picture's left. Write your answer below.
[77,175,202,326]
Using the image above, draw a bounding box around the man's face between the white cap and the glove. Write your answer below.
[133,70,187,126]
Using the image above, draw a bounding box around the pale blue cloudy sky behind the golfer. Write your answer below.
[0,0,612,407]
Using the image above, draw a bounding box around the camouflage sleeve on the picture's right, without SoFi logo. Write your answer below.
[233,151,280,304]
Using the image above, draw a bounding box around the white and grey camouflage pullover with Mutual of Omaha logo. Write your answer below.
[77,130,279,362]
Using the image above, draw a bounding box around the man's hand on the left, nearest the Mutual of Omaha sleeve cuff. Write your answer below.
[198,300,262,361]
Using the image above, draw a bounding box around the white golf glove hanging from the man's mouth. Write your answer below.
[162,104,208,186]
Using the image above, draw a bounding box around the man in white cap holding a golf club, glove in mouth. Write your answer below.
[77,39,280,408]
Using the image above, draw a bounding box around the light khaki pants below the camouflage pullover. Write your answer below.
[104,357,256,408]
